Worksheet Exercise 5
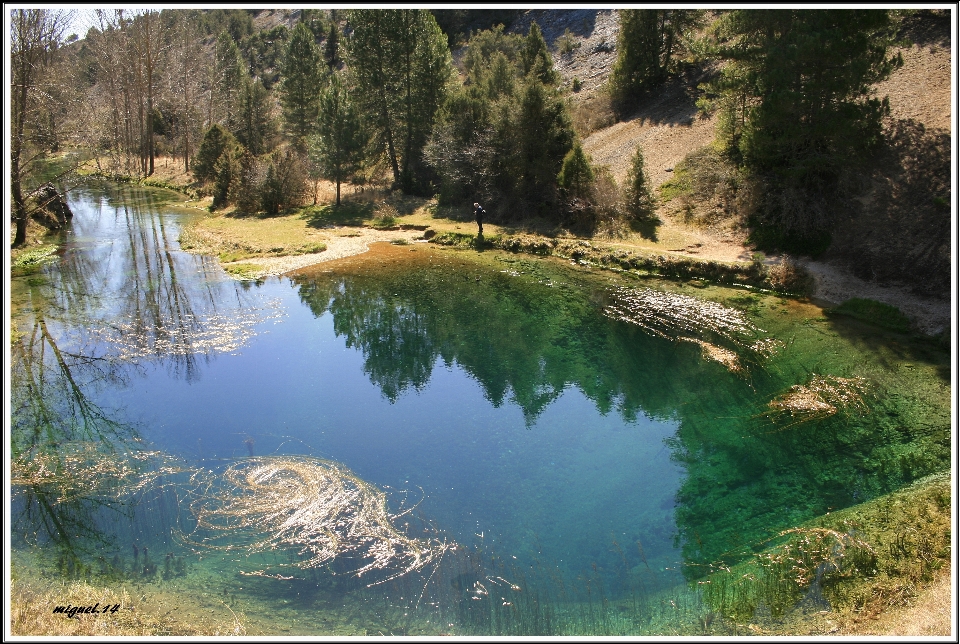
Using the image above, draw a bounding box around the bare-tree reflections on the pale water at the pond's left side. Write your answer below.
[10,188,277,559]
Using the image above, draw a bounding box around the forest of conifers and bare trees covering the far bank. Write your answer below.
[10,9,949,272]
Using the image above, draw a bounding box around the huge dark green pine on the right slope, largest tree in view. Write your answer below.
[700,9,900,251]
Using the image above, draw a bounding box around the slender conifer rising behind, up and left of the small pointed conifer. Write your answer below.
[280,22,323,147]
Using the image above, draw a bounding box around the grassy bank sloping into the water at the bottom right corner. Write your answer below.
[699,472,951,635]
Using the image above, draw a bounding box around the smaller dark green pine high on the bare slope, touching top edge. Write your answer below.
[609,9,703,115]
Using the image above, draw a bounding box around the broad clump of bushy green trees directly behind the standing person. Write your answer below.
[424,27,574,220]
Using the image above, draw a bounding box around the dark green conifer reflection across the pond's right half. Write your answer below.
[297,249,950,579]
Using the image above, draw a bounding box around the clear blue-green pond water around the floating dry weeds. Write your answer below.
[10,185,950,634]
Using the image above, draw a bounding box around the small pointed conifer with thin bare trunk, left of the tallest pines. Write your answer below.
[310,74,367,206]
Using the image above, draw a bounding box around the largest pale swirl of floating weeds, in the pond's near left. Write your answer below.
[192,456,453,585]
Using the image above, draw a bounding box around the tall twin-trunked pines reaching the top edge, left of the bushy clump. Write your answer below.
[347,9,453,194]
